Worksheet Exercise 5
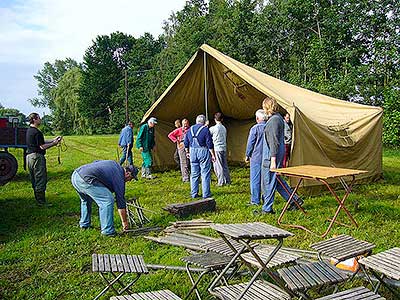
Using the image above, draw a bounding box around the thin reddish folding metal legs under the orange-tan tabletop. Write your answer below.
[277,172,358,238]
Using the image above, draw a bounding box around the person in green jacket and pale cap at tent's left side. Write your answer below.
[136,117,157,179]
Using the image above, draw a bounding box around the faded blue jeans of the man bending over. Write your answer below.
[71,171,115,235]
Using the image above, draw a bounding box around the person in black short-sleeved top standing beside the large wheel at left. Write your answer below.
[26,113,62,206]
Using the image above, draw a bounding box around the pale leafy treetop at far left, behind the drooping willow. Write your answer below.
[29,58,78,110]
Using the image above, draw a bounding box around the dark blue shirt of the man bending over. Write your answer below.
[76,160,126,209]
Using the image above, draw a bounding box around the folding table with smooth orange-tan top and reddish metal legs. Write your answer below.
[271,165,367,237]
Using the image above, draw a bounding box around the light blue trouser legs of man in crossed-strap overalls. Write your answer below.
[190,148,211,198]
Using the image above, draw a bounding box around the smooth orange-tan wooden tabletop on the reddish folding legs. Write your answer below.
[270,165,368,179]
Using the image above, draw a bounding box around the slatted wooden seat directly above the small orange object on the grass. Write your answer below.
[311,234,375,262]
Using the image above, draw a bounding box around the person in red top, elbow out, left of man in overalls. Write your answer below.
[168,119,190,182]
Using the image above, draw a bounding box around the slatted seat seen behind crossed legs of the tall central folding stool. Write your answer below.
[242,245,301,269]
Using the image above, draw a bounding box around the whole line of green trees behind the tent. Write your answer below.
[26,0,400,146]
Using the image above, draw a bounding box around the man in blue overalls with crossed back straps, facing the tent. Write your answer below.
[184,115,215,198]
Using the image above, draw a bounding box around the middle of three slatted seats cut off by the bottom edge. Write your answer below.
[210,280,290,300]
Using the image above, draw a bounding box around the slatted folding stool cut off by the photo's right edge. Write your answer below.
[359,248,400,298]
